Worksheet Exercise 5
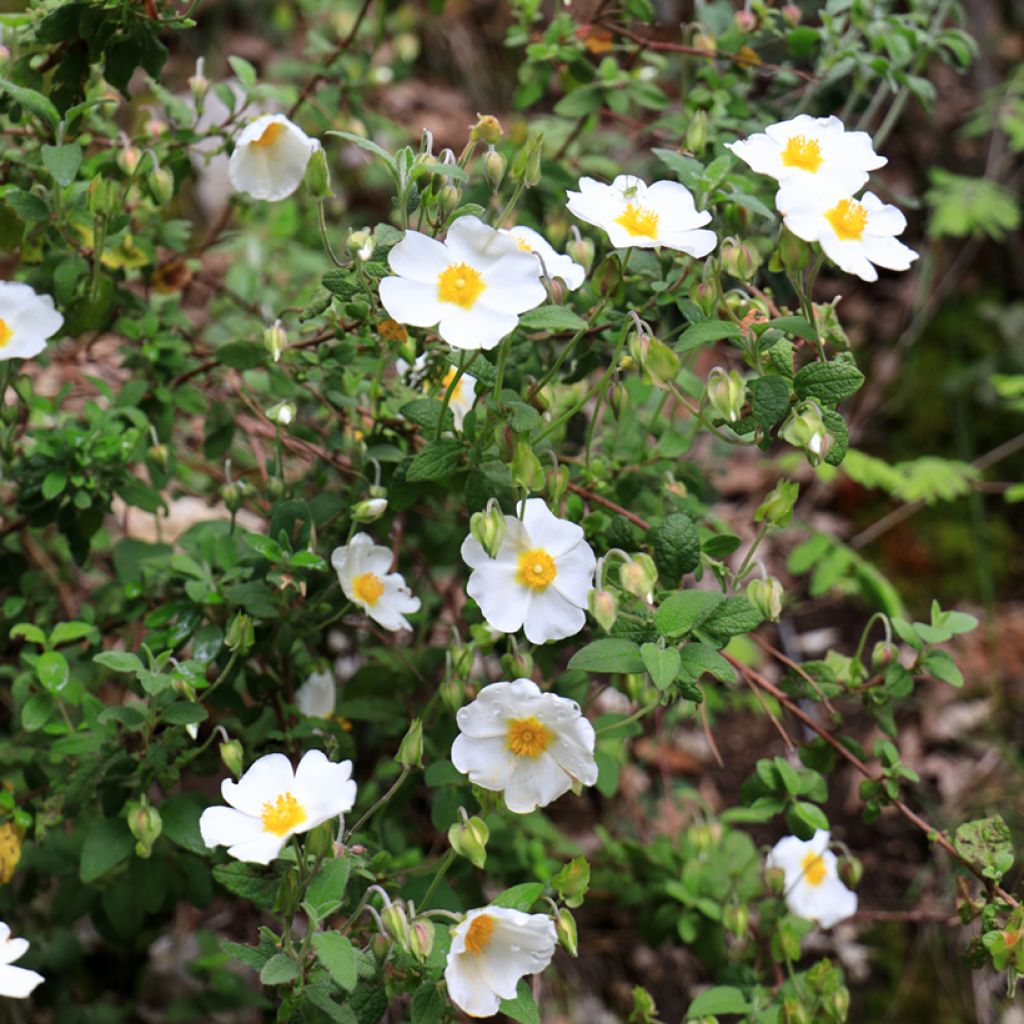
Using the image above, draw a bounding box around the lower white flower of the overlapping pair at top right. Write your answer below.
[783,189,918,281]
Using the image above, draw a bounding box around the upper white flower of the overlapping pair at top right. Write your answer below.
[725,114,888,212]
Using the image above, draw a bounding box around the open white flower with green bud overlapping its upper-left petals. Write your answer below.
[462,498,597,643]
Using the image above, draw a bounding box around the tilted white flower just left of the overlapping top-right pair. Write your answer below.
[567,174,718,258]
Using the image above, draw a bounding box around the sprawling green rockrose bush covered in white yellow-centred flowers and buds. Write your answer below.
[0,0,1024,1024]
